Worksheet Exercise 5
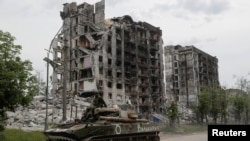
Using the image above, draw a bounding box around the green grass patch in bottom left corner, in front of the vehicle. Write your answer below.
[0,129,46,141]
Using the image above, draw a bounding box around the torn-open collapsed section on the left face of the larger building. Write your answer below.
[70,29,105,97]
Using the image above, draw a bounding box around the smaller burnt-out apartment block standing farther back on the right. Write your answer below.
[164,45,219,107]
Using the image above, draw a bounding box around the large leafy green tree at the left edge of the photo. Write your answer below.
[0,30,37,129]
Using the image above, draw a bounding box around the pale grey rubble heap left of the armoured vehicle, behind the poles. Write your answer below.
[6,95,90,130]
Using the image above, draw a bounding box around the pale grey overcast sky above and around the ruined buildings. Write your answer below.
[0,0,250,88]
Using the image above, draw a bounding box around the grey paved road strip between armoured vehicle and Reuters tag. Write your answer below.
[160,132,207,141]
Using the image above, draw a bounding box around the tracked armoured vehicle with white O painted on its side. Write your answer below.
[44,105,160,141]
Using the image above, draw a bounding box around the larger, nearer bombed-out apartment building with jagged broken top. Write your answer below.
[49,0,164,118]
